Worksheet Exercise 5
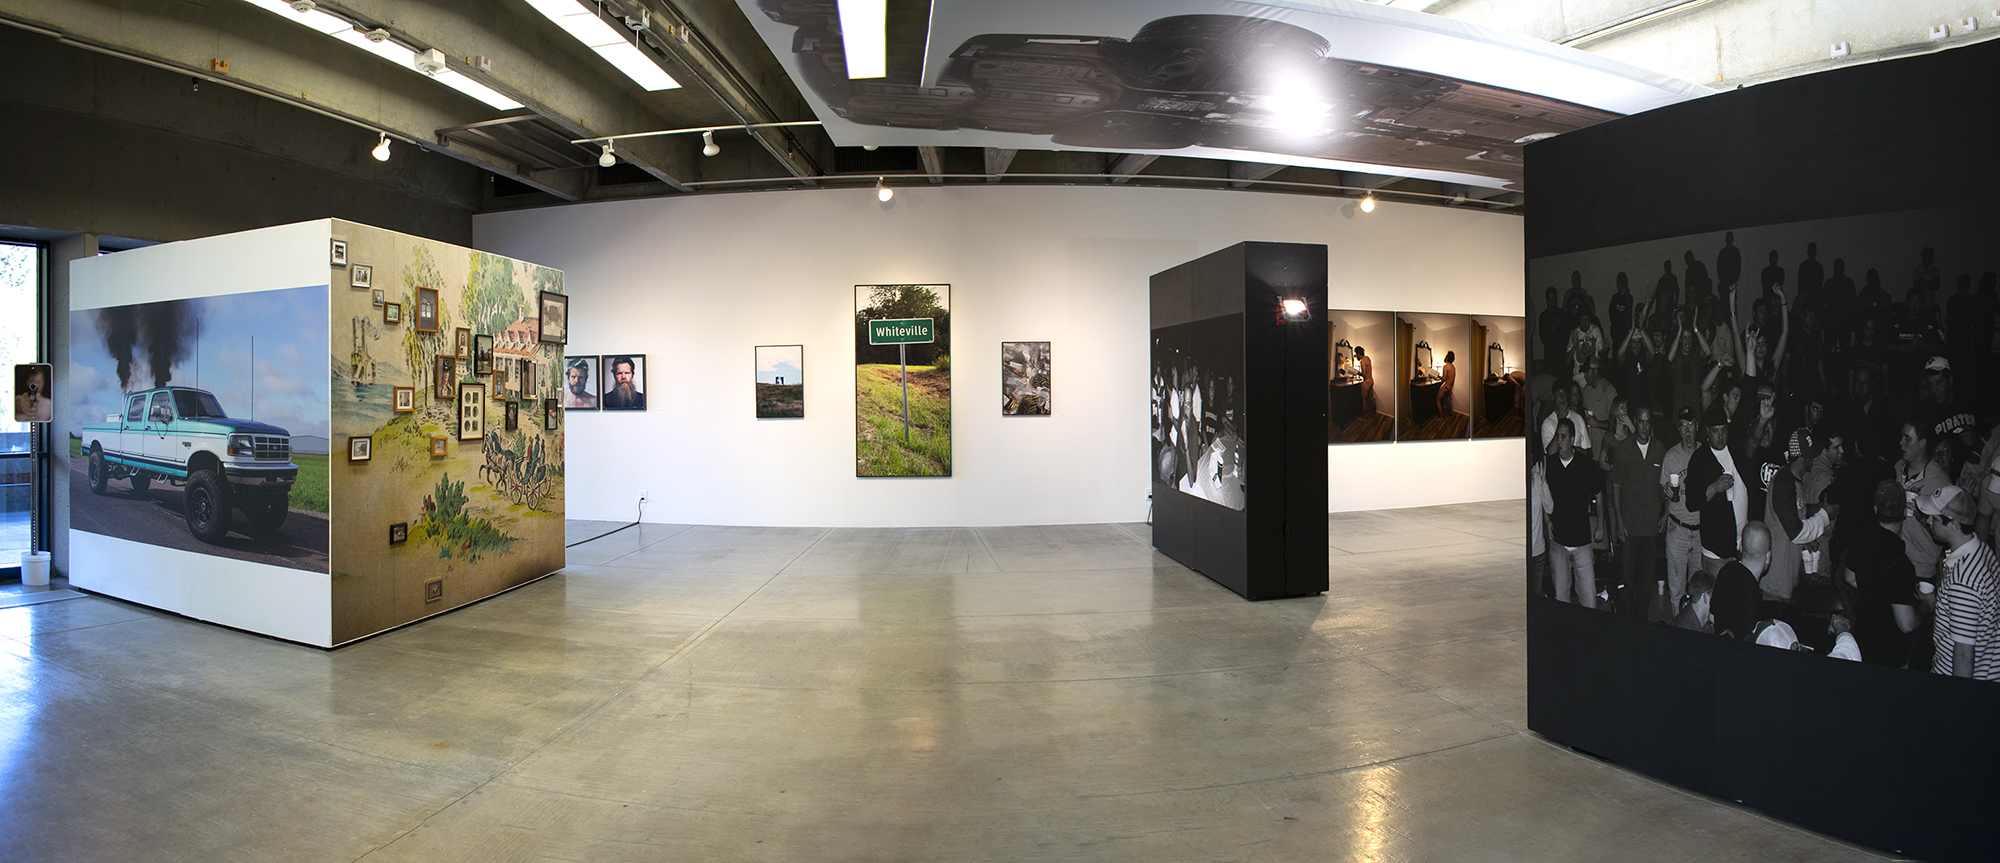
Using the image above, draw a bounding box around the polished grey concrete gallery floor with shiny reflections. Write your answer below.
[0,501,1876,861]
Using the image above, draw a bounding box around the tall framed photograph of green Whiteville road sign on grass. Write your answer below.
[854,284,952,477]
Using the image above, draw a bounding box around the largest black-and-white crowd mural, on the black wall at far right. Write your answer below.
[1526,206,2000,679]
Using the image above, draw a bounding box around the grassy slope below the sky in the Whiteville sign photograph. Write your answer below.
[856,364,952,475]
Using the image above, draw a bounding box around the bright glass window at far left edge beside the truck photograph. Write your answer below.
[0,242,42,569]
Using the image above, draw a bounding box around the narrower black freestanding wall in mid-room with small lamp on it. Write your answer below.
[1152,242,1328,599]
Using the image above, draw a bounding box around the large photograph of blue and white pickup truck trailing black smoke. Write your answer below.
[70,286,330,571]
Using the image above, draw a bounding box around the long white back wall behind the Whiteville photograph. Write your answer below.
[474,186,1524,527]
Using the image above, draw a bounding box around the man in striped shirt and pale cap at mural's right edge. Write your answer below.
[1916,485,2000,679]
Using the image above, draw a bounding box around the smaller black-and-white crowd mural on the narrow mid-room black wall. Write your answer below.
[1152,316,1244,511]
